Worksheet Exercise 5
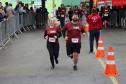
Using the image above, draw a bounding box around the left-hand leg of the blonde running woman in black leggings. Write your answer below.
[47,43,55,69]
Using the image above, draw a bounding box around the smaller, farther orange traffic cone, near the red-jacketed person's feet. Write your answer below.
[96,36,105,58]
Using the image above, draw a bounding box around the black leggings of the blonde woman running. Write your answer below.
[47,42,59,66]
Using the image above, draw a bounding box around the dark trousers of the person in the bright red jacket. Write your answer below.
[89,30,100,52]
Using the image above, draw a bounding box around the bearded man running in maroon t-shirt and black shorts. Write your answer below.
[63,15,85,71]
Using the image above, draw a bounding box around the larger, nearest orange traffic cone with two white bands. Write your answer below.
[104,47,118,76]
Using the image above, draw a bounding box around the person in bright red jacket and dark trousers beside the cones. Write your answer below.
[87,8,102,53]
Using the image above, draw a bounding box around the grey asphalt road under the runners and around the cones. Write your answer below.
[0,29,126,84]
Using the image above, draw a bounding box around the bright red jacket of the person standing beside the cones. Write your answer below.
[87,13,102,31]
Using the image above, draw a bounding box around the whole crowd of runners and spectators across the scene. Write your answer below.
[0,1,126,71]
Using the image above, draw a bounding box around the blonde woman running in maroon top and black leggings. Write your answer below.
[44,18,61,69]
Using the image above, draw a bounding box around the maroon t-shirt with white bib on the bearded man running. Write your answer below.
[64,22,84,43]
